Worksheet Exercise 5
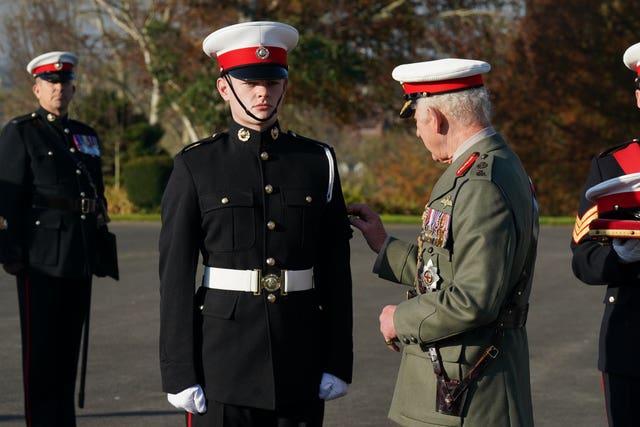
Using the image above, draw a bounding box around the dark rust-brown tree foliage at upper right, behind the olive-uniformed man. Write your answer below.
[490,0,640,215]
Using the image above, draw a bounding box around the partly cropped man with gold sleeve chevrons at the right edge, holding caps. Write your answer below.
[571,39,640,426]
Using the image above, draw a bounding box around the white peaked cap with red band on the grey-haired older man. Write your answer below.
[391,58,491,117]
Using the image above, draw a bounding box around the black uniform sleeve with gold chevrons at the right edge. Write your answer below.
[571,156,640,285]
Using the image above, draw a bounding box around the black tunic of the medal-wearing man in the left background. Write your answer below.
[0,108,106,278]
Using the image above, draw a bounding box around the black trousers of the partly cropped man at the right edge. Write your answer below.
[602,372,640,427]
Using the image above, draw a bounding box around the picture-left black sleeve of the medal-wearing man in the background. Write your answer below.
[0,118,31,263]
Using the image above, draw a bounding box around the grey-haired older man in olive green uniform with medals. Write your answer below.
[348,59,538,427]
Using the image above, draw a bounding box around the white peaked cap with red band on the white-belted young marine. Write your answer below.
[202,21,298,80]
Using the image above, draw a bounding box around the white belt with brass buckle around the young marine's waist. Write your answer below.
[202,266,313,294]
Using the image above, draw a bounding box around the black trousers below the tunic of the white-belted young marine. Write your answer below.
[186,399,324,427]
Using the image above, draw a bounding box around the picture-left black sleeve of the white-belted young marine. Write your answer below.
[159,154,200,393]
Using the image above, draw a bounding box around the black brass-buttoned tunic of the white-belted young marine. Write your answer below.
[159,123,353,409]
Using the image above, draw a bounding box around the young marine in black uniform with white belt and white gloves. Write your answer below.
[159,22,353,427]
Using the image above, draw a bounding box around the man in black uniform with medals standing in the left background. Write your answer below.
[0,51,112,427]
